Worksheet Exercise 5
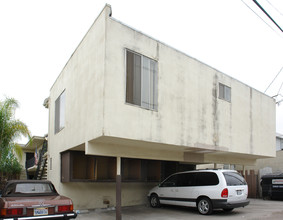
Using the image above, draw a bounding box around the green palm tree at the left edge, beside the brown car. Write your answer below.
[0,98,30,168]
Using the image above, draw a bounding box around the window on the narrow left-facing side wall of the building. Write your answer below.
[55,91,66,134]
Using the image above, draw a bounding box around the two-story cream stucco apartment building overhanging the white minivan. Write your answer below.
[48,5,275,209]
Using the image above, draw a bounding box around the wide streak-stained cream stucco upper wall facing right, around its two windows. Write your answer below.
[101,12,275,159]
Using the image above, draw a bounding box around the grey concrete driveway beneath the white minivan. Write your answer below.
[77,199,283,220]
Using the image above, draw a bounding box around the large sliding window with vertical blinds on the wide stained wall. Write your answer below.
[126,50,157,110]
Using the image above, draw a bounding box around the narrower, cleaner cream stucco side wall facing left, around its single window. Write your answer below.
[48,5,109,185]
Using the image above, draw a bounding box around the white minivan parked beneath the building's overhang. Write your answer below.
[148,169,249,215]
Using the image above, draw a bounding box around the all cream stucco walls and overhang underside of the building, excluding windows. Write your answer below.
[48,5,275,209]
